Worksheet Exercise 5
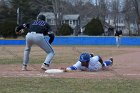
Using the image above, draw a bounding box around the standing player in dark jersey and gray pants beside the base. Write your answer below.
[16,15,55,71]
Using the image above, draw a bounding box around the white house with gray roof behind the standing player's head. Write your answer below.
[39,12,80,35]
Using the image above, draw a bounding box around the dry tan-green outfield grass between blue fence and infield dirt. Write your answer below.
[0,46,129,64]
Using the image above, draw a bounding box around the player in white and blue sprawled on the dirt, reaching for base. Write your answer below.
[62,52,113,72]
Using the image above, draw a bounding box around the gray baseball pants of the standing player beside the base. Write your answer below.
[23,32,55,65]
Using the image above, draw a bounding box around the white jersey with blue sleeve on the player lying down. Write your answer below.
[67,56,102,71]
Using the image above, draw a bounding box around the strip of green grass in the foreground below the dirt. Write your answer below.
[0,77,140,93]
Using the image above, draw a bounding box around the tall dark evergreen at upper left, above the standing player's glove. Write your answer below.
[10,0,39,23]
